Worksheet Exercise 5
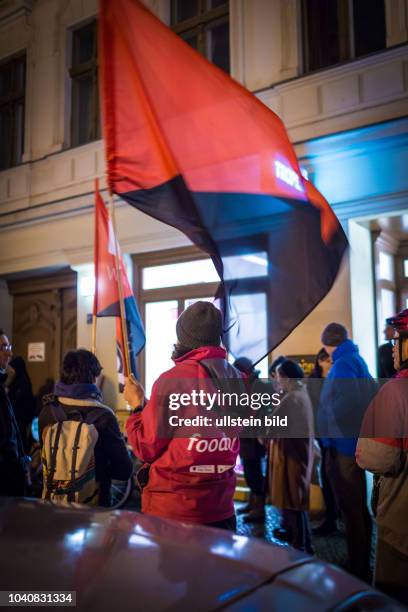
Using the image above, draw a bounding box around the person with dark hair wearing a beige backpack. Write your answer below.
[39,349,133,506]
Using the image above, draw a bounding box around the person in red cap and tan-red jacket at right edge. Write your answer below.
[356,309,408,605]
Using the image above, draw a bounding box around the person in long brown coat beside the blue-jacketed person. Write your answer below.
[269,359,314,554]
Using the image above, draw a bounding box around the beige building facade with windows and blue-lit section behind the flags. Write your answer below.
[0,0,408,409]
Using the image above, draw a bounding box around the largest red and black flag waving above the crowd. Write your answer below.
[99,0,347,361]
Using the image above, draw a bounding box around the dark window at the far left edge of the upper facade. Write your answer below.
[0,49,27,172]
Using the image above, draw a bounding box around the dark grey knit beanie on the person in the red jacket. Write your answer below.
[176,301,223,349]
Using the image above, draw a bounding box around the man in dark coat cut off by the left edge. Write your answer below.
[0,330,25,496]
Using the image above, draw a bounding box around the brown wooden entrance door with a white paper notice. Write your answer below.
[9,271,77,393]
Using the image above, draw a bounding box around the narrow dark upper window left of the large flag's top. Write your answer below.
[68,16,102,147]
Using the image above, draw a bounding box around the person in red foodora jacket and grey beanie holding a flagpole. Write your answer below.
[124,301,243,529]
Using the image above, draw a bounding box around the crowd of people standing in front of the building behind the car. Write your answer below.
[0,301,408,603]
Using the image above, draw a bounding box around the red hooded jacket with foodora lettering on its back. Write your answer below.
[126,346,241,524]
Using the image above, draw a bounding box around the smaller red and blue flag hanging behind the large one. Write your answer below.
[93,184,145,388]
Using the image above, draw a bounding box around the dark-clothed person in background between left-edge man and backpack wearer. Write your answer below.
[7,357,35,454]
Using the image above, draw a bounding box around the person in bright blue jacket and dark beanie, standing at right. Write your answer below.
[317,323,374,581]
